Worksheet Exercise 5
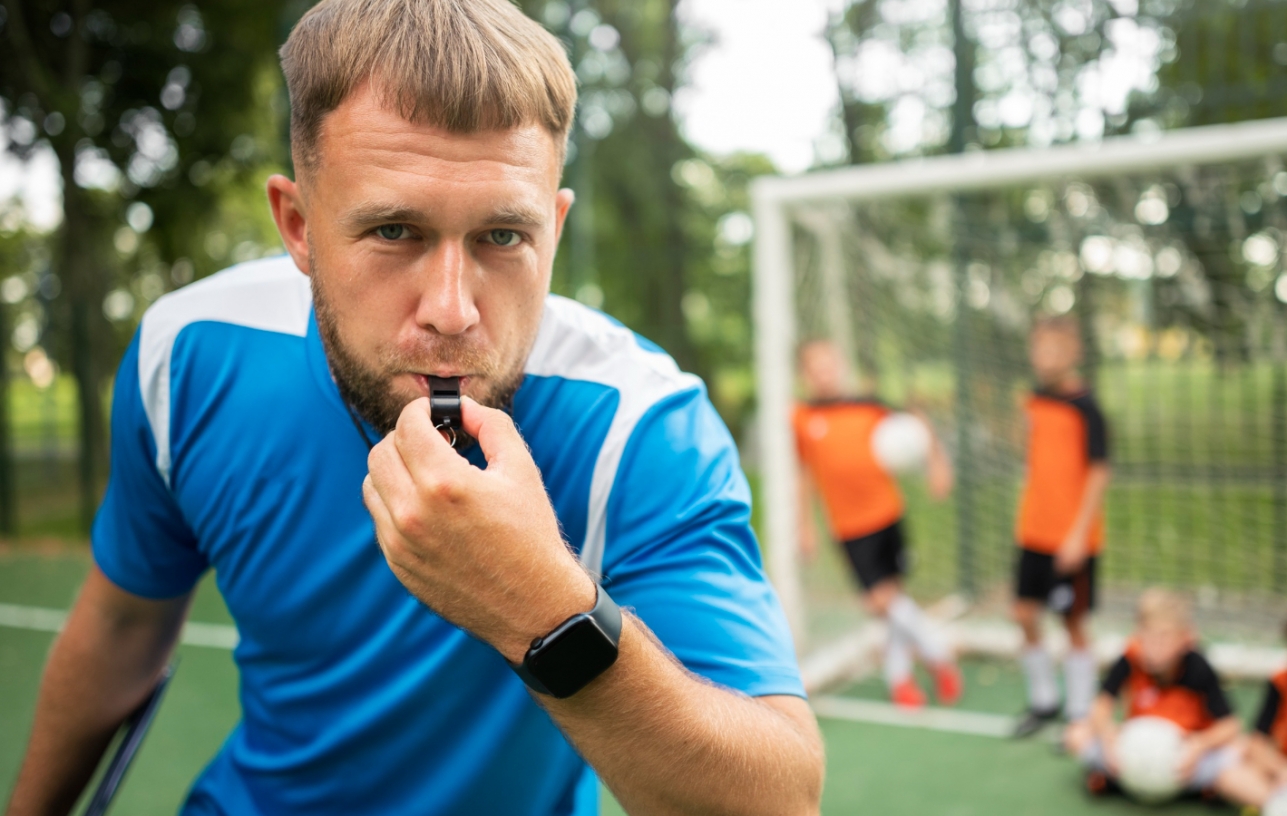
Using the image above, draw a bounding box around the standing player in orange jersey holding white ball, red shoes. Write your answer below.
[793,341,961,708]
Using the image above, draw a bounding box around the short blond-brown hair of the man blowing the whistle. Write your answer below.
[288,0,577,167]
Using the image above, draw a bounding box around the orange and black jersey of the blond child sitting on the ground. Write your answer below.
[1100,644,1233,731]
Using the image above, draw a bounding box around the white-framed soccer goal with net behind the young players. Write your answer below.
[752,120,1287,674]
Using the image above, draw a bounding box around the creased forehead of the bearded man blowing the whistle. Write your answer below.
[311,82,562,189]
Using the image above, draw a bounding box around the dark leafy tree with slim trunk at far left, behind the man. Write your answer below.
[0,0,289,526]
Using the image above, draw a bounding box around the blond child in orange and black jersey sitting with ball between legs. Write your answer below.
[1064,589,1273,807]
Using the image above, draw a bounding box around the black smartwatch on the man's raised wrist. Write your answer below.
[514,584,622,699]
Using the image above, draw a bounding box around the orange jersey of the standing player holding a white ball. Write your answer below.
[792,399,903,541]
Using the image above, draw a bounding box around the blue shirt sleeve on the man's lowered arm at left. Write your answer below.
[90,333,207,598]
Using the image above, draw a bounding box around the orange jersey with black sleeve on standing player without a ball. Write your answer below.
[1015,390,1108,555]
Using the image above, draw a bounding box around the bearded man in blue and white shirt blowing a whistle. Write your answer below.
[9,0,822,816]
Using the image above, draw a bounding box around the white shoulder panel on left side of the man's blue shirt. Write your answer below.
[139,255,313,485]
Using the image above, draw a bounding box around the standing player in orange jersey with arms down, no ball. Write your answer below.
[1014,317,1111,736]
